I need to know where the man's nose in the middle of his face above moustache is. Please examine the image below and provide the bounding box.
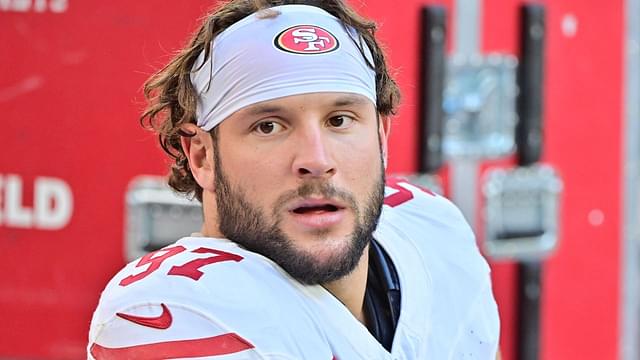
[292,128,336,178]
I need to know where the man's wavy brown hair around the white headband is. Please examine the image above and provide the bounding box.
[140,0,400,201]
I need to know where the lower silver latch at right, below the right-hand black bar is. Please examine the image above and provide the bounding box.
[482,165,562,260]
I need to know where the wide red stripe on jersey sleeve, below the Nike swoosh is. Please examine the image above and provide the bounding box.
[91,333,254,360]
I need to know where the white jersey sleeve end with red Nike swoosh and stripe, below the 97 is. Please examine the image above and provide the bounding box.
[87,303,270,360]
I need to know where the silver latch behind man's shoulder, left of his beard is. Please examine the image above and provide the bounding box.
[125,176,202,261]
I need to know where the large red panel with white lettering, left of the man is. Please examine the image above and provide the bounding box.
[0,0,215,359]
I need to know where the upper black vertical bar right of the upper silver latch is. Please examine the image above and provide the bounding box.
[516,4,545,166]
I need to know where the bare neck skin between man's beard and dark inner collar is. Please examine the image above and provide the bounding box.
[322,246,369,325]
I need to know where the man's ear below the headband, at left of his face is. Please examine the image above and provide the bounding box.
[180,124,215,191]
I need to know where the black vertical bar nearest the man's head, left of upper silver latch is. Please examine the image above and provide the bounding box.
[418,6,447,173]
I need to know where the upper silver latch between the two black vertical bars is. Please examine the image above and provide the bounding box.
[442,54,518,159]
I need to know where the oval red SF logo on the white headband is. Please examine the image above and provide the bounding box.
[273,25,339,54]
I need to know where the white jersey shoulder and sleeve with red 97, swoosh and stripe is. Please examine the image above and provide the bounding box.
[87,239,331,360]
